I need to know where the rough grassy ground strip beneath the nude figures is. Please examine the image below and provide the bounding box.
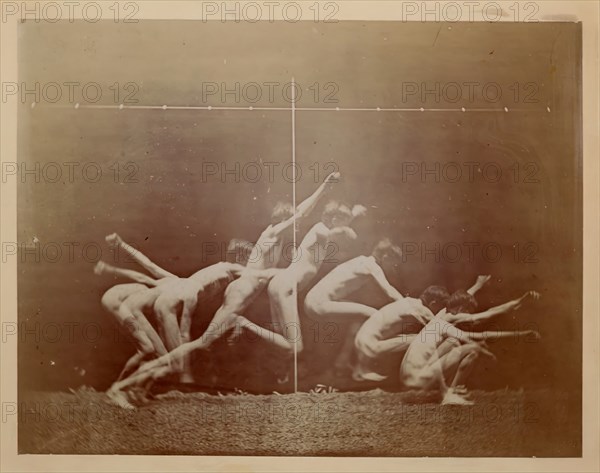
[19,389,580,457]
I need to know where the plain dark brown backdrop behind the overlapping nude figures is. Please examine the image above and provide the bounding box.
[18,21,582,402]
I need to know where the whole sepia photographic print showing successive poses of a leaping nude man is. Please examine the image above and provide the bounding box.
[2,2,597,471]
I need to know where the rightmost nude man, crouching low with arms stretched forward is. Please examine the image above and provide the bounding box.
[400,291,540,405]
